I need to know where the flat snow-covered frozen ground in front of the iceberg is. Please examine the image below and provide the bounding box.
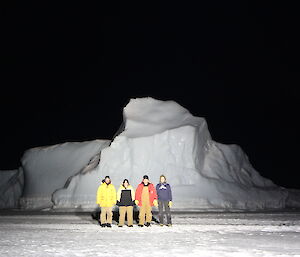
[0,211,300,257]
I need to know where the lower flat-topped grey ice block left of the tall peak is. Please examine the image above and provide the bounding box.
[20,140,110,209]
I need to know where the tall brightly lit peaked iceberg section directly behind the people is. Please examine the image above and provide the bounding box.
[53,97,288,210]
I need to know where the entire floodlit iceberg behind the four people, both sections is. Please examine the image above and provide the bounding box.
[0,97,300,210]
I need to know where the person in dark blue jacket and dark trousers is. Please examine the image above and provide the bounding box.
[156,175,172,226]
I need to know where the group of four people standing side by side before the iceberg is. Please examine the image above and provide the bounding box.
[97,175,172,227]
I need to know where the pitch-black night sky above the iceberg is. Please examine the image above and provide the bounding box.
[0,0,300,188]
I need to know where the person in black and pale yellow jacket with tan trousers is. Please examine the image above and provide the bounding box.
[117,179,135,227]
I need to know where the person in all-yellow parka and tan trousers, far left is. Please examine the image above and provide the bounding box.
[97,176,117,227]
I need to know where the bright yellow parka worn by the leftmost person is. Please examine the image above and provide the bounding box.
[97,182,117,207]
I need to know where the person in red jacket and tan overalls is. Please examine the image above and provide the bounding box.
[135,175,158,227]
